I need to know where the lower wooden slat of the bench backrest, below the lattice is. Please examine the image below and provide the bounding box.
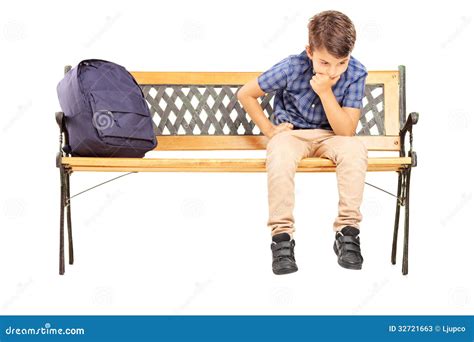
[155,135,400,151]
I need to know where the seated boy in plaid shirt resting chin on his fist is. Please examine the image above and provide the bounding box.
[238,11,367,274]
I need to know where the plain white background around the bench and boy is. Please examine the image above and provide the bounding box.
[0,0,474,314]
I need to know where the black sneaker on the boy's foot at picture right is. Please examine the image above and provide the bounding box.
[333,226,364,270]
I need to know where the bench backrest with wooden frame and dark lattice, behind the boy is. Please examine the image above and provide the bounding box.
[132,66,405,151]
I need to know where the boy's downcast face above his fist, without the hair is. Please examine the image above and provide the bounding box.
[306,45,350,79]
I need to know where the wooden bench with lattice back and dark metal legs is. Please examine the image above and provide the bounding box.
[56,66,418,275]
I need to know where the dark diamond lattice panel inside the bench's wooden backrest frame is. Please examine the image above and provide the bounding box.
[142,84,385,135]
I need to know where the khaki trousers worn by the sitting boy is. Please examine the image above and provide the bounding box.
[266,129,367,236]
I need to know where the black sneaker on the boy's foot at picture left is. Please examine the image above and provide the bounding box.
[271,233,298,274]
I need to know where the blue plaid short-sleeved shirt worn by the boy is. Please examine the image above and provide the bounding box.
[258,51,367,130]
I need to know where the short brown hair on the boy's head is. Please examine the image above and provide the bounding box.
[308,11,356,58]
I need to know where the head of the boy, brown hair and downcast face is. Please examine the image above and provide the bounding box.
[306,11,356,78]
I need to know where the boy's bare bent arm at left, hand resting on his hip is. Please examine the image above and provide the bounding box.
[237,78,293,138]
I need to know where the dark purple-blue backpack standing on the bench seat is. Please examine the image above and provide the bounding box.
[57,59,157,158]
